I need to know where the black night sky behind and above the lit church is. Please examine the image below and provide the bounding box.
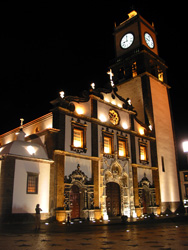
[0,0,188,167]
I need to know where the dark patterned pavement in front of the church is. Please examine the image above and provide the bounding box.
[0,223,188,250]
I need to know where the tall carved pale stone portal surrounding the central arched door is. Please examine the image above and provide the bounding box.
[101,152,136,219]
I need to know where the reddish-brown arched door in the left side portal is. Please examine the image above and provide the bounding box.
[70,185,80,219]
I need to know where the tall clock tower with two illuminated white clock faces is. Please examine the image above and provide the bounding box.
[110,11,180,212]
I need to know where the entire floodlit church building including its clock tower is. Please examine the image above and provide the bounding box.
[0,11,180,221]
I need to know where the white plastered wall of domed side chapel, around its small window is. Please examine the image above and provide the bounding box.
[12,159,50,213]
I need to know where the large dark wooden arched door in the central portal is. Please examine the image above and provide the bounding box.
[106,182,121,217]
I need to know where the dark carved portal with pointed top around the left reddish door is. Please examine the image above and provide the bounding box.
[64,164,94,220]
